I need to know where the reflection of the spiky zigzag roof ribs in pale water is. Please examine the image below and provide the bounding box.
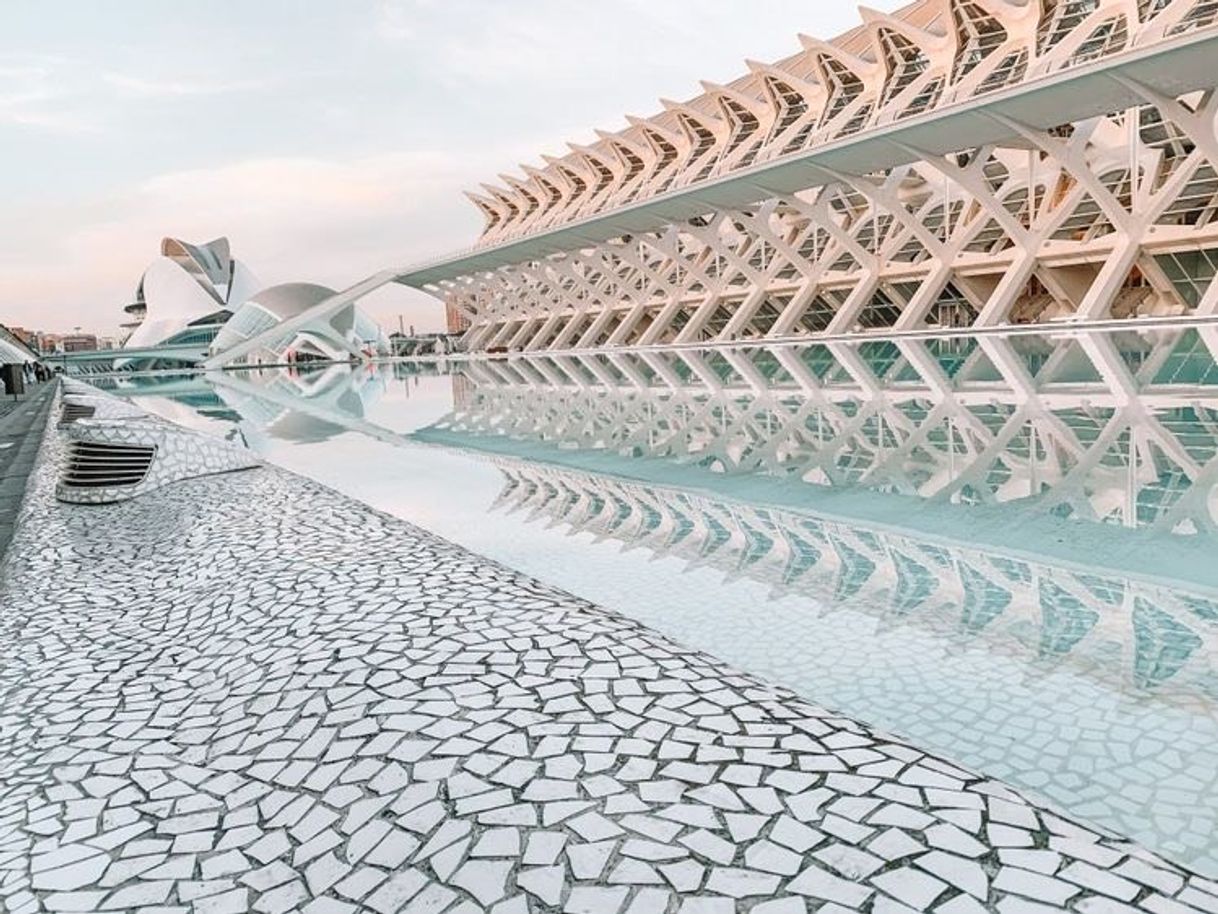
[496,462,1218,687]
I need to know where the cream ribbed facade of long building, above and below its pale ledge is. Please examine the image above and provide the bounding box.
[431,0,1218,351]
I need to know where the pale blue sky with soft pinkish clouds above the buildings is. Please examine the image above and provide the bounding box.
[0,0,898,335]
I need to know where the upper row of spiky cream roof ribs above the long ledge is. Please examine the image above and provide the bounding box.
[468,0,1218,244]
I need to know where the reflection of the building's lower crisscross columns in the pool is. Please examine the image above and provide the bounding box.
[435,328,1218,535]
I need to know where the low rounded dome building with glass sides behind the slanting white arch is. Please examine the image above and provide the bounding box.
[211,283,392,364]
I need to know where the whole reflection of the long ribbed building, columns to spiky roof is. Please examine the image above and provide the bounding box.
[417,330,1218,687]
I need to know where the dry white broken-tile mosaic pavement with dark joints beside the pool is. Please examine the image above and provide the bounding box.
[0,402,1218,914]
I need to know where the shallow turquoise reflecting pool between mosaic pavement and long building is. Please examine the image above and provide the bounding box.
[102,334,1218,874]
